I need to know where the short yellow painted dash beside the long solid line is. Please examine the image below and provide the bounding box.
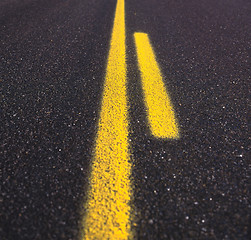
[134,33,179,138]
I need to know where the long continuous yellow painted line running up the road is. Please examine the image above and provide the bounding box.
[84,0,131,239]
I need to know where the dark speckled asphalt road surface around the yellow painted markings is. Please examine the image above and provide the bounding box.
[0,0,251,240]
